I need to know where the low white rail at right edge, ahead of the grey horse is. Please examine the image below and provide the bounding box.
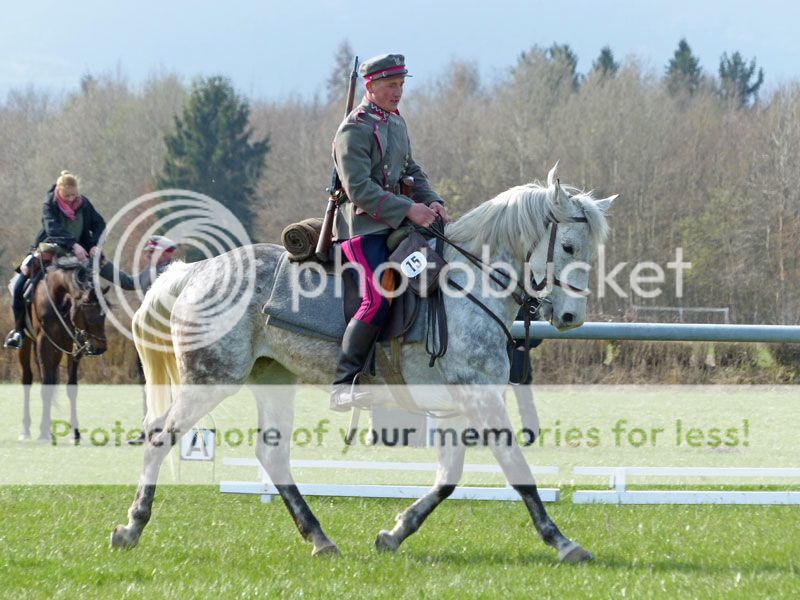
[572,467,800,504]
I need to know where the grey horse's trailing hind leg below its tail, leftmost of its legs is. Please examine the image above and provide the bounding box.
[111,386,229,549]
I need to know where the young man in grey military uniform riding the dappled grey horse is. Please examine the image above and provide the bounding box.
[331,54,449,411]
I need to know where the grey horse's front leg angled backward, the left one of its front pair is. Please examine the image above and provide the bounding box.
[375,417,467,552]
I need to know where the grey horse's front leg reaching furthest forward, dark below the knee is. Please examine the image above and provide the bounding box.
[470,391,593,563]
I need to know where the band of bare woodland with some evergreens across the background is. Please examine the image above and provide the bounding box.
[0,40,800,324]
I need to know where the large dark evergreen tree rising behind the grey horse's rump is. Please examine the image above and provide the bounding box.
[155,76,269,243]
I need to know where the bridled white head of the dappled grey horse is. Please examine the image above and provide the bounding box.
[529,167,618,330]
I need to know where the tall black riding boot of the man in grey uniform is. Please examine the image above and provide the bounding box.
[331,319,380,411]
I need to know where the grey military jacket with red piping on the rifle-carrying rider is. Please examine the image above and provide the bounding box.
[333,98,444,240]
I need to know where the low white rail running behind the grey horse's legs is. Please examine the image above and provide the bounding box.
[219,458,560,502]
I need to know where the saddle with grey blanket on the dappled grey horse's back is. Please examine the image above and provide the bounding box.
[262,247,427,343]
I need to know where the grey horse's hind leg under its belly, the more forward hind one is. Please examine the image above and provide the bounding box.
[253,386,339,556]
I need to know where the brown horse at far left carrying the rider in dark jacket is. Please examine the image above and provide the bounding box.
[19,257,106,443]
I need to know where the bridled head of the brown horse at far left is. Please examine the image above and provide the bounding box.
[67,265,108,356]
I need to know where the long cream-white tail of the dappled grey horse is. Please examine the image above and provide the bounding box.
[132,262,192,428]
